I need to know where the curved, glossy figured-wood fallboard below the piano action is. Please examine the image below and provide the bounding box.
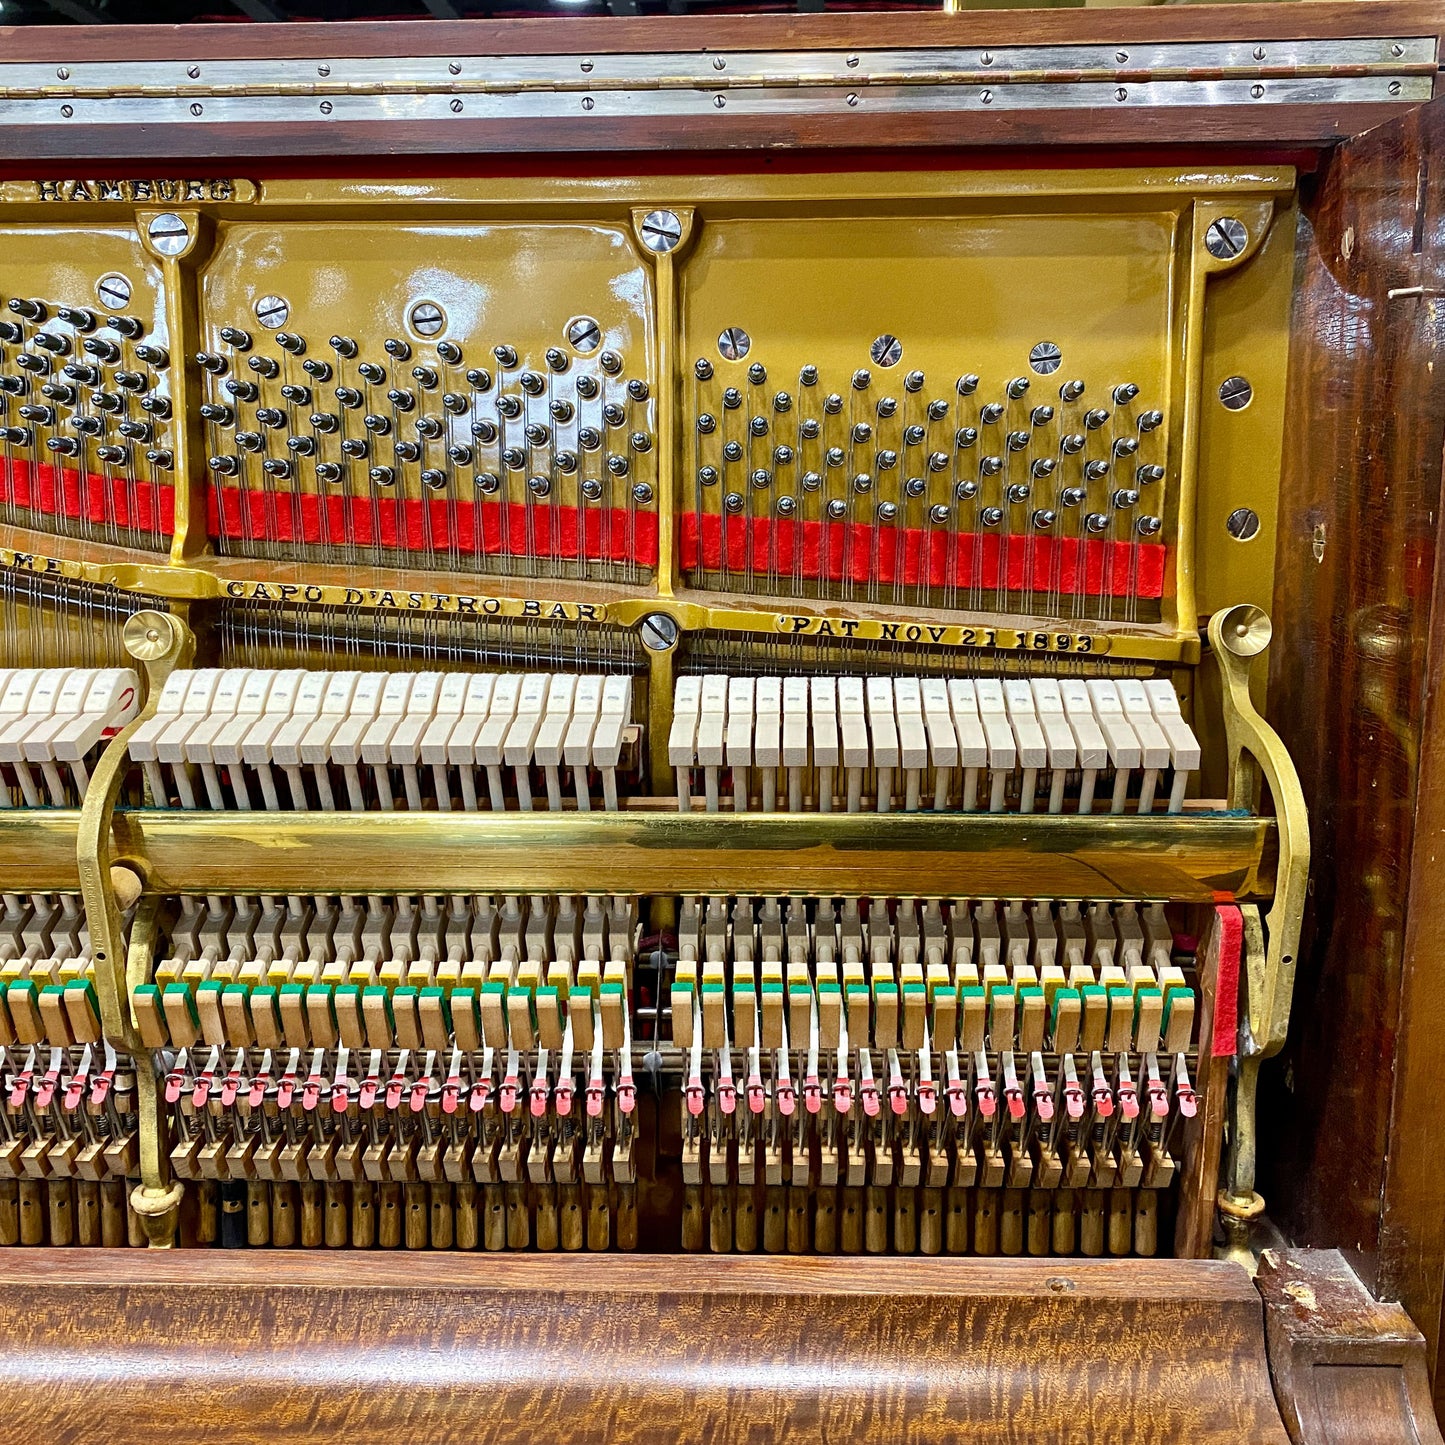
[0,1250,1285,1445]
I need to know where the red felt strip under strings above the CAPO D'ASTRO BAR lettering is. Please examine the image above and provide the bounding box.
[207,487,657,566]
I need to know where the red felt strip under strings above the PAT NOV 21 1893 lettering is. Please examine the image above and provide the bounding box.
[679,512,1165,598]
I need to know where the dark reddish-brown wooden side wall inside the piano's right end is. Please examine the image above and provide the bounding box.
[1260,90,1445,1375]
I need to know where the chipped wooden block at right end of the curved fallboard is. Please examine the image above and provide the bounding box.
[1256,1250,1442,1445]
